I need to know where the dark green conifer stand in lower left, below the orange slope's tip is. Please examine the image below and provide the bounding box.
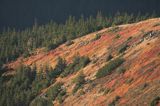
[0,56,89,106]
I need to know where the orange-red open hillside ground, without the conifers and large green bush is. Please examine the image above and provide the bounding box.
[6,18,160,106]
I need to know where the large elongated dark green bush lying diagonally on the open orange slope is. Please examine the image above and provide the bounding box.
[96,57,124,78]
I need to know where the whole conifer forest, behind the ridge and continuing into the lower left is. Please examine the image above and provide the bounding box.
[0,12,156,106]
